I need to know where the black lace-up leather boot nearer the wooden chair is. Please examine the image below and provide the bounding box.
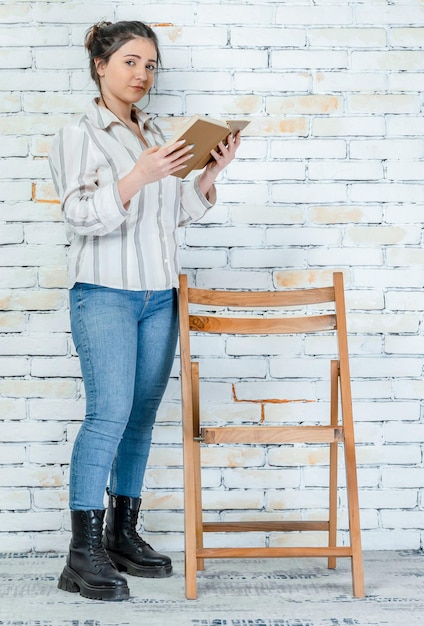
[103,494,172,578]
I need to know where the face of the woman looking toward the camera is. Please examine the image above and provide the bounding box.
[95,37,157,104]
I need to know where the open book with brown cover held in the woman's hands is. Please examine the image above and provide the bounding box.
[165,115,249,178]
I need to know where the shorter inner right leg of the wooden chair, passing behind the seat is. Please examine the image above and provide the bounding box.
[328,360,339,569]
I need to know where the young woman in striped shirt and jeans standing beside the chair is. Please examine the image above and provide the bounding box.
[49,22,240,600]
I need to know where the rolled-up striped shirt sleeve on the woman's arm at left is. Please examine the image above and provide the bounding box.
[49,125,128,236]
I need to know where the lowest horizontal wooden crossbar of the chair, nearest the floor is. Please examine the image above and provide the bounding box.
[198,547,352,559]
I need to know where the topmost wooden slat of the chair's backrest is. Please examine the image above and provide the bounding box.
[188,286,334,308]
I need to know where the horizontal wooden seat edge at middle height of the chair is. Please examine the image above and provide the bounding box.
[200,426,343,444]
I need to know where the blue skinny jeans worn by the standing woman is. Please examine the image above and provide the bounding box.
[69,283,178,510]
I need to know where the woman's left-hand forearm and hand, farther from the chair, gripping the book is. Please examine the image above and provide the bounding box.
[118,140,193,208]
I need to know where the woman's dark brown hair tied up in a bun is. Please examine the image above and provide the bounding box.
[84,21,161,91]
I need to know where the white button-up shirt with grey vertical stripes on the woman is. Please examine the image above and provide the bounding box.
[49,100,212,290]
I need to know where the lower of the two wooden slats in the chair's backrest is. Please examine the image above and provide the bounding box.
[189,314,336,335]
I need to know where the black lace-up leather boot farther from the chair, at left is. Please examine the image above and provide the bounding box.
[58,510,130,600]
